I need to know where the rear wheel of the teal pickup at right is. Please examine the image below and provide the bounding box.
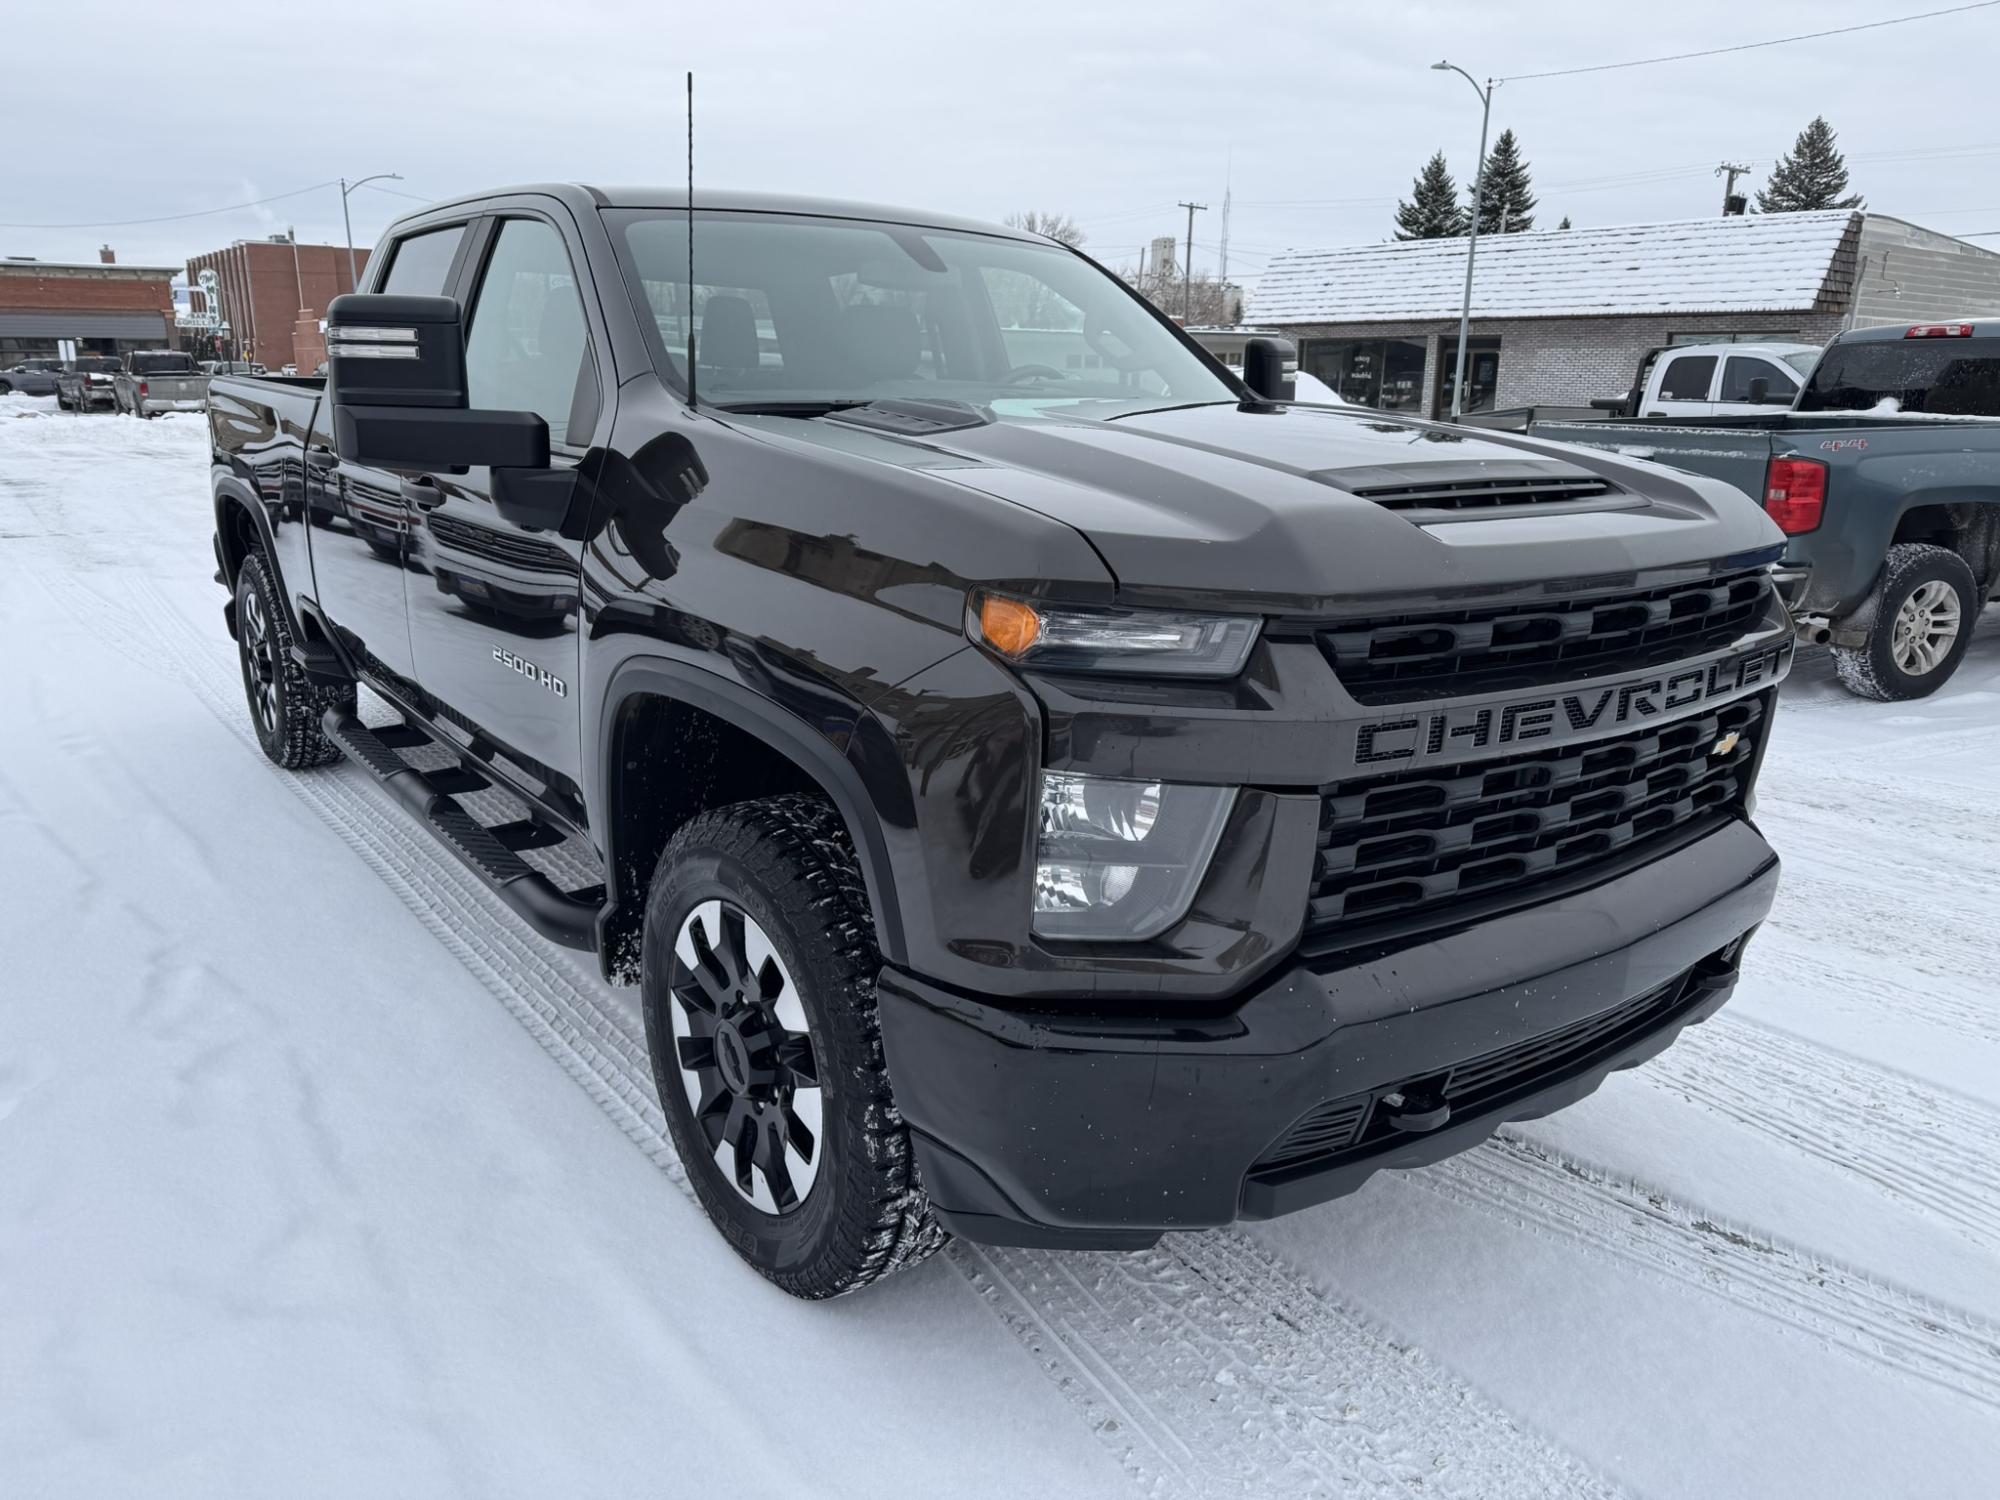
[1834,542,1980,702]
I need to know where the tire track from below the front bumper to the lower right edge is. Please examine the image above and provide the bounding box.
[1408,1136,2000,1410]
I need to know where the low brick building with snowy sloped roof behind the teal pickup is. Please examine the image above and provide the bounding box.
[1252,210,2000,416]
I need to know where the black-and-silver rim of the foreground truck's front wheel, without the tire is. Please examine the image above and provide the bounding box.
[668,900,822,1214]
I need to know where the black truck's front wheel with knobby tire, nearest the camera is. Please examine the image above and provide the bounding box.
[640,796,944,1298]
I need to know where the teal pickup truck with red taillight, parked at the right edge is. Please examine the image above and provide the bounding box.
[1530,322,2000,700]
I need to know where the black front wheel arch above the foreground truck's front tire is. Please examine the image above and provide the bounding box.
[592,656,904,980]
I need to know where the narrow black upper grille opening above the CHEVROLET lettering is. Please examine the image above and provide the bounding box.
[1314,568,1770,704]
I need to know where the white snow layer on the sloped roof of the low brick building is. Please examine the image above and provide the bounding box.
[1256,210,1860,324]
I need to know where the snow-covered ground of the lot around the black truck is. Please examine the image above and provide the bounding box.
[0,398,2000,1500]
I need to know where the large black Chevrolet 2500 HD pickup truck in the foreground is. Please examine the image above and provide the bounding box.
[210,186,1792,1296]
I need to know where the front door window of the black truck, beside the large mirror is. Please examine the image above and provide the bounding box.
[466,218,586,442]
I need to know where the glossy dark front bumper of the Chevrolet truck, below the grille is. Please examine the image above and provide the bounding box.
[878,820,1778,1248]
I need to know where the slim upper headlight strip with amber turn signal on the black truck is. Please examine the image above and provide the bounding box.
[966,594,1262,678]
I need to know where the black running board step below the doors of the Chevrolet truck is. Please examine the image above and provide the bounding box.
[320,708,604,950]
